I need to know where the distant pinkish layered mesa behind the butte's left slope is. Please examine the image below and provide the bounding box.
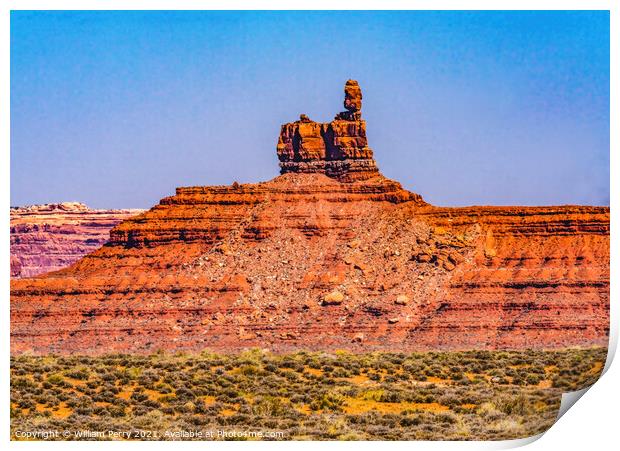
[11,202,143,278]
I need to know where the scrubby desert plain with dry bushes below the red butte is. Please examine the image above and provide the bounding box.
[11,348,606,440]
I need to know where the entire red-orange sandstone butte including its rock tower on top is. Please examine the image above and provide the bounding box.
[11,81,610,354]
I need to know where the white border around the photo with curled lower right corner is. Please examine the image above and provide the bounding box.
[0,0,620,451]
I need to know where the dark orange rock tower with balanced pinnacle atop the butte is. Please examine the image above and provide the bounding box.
[277,80,379,182]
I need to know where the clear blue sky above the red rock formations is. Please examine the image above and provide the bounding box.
[11,11,609,208]
